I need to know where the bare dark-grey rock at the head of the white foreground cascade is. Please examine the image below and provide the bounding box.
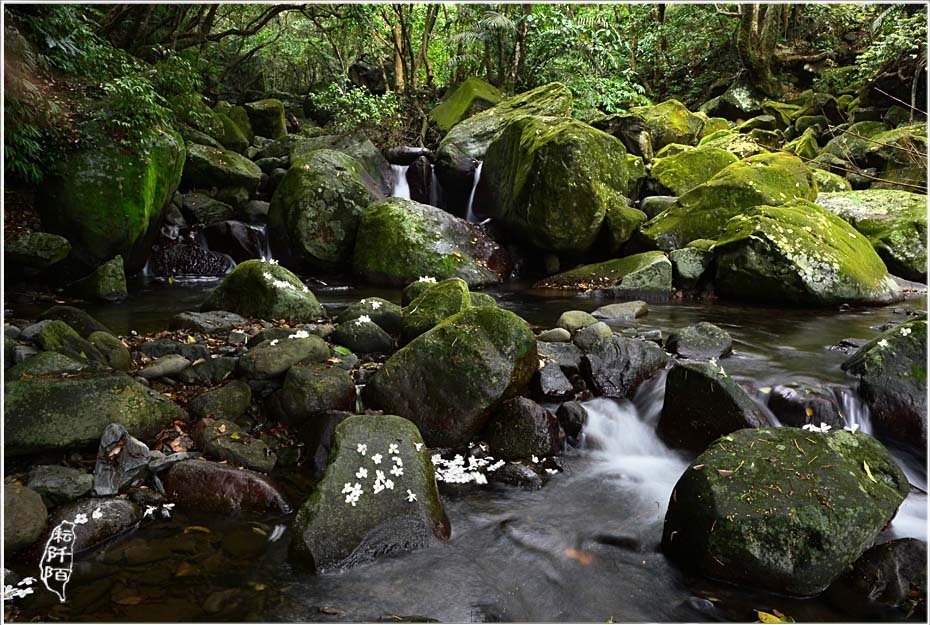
[581,334,668,397]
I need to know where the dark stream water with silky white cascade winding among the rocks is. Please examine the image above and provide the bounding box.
[7,282,927,622]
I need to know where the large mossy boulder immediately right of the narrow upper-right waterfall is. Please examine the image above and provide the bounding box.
[475,116,635,253]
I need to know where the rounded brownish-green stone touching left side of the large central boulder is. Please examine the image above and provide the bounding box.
[273,363,355,426]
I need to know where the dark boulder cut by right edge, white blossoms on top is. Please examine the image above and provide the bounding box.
[843,319,927,458]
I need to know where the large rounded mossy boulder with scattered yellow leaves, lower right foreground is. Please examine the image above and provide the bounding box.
[662,428,908,596]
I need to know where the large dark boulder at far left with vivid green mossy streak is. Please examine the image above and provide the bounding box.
[36,128,185,274]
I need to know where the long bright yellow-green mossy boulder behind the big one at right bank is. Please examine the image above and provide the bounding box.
[640,153,817,250]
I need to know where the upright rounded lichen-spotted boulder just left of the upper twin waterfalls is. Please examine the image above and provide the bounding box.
[268,150,374,270]
